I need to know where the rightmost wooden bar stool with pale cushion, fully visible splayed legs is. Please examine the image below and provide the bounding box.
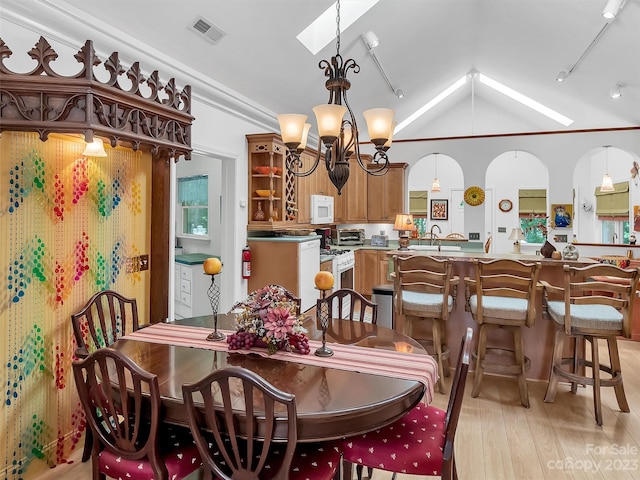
[543,264,639,425]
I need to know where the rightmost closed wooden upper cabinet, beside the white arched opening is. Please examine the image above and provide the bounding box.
[366,163,408,223]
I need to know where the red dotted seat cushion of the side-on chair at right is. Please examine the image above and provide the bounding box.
[343,404,447,476]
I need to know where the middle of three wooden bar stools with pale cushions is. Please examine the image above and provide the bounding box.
[465,259,541,408]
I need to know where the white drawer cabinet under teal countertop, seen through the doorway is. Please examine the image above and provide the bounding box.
[174,262,214,318]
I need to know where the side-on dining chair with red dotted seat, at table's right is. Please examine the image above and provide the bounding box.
[343,328,473,480]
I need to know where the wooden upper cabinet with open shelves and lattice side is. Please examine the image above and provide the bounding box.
[247,133,298,230]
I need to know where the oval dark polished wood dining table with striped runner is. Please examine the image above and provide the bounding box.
[114,314,433,442]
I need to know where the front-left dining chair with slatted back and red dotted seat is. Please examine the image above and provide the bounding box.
[73,348,202,480]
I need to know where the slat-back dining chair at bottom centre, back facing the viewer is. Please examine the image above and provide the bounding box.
[182,367,341,480]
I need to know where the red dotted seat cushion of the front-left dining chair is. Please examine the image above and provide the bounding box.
[98,427,202,480]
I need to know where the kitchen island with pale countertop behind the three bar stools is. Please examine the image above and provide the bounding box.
[387,250,598,380]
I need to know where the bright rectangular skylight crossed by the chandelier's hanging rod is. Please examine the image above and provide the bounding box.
[296,0,379,55]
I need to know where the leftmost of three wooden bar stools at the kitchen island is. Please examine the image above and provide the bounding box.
[394,255,459,393]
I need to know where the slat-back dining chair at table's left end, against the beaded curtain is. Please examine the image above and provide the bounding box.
[71,290,139,462]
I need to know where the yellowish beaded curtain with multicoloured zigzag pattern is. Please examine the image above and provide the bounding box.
[0,132,151,480]
